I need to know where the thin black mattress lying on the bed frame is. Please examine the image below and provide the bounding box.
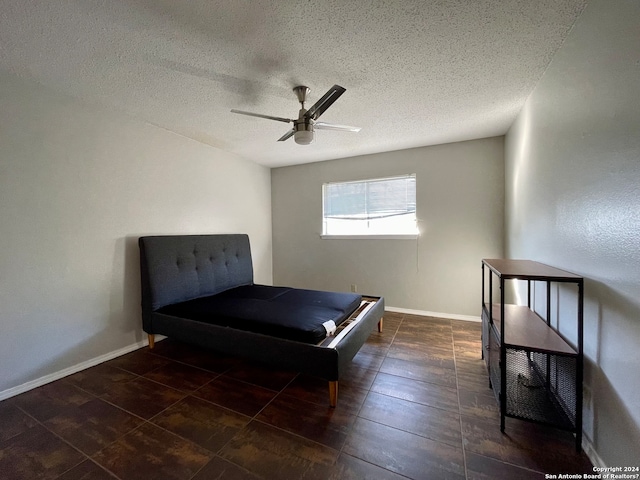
[157,284,362,343]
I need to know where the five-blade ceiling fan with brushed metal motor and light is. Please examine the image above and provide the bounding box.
[231,85,360,145]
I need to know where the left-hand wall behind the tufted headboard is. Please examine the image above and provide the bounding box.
[0,73,272,398]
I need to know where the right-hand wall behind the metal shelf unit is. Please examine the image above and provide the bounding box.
[505,0,640,466]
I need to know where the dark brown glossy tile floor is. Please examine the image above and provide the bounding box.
[0,313,591,480]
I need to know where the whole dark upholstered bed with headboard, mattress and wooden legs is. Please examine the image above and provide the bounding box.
[138,234,384,407]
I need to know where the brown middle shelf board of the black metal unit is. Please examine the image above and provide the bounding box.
[485,303,577,355]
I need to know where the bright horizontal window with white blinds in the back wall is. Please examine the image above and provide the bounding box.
[322,174,418,236]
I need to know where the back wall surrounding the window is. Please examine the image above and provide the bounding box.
[271,137,504,317]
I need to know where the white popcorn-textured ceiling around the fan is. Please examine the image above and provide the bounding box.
[0,0,586,166]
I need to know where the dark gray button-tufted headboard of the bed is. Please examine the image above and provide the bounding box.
[138,234,253,330]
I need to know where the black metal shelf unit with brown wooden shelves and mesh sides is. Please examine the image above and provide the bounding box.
[482,259,584,451]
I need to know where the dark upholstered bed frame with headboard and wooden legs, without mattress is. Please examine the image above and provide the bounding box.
[138,234,384,407]
